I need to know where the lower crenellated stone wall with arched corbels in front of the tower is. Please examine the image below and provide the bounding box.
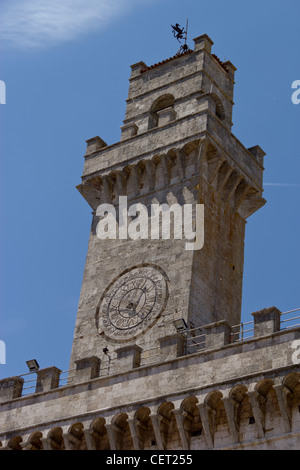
[0,307,300,450]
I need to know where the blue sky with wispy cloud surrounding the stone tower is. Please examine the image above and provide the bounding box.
[0,0,300,377]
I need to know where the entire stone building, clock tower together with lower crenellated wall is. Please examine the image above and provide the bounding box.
[0,35,300,452]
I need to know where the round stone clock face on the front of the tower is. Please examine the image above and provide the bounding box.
[98,266,168,341]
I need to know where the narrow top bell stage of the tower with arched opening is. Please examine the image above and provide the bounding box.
[122,34,236,139]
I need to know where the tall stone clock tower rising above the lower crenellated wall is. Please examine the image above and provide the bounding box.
[70,35,265,382]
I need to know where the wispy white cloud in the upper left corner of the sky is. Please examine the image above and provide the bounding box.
[1,0,143,49]
